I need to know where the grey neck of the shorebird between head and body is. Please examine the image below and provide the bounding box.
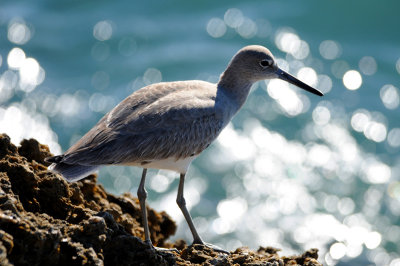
[217,68,253,108]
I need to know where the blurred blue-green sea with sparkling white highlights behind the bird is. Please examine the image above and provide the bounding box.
[0,0,400,266]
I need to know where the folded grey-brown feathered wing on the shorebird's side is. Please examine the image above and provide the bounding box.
[62,82,223,165]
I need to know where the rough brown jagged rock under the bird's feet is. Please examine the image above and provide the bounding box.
[0,134,321,265]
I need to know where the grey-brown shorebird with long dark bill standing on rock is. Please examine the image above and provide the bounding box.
[47,45,323,250]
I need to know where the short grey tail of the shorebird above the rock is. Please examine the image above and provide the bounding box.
[45,155,100,182]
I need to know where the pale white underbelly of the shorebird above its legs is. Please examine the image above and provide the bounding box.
[123,155,197,174]
